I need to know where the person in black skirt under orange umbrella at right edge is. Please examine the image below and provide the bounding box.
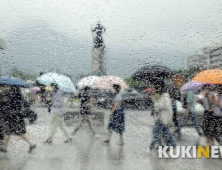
[201,85,222,146]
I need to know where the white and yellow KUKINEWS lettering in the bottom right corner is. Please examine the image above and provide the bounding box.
[158,146,222,159]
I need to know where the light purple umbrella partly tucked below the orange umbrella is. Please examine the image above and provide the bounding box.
[180,80,206,93]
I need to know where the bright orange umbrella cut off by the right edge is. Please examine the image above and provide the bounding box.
[192,69,222,84]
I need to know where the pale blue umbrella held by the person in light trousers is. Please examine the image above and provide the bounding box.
[37,72,76,93]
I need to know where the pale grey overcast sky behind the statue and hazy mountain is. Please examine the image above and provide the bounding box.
[0,0,222,77]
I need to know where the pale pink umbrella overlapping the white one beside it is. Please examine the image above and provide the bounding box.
[95,76,129,90]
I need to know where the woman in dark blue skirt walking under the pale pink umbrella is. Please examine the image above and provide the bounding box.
[104,84,125,145]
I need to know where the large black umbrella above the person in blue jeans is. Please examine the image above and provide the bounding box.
[133,65,173,84]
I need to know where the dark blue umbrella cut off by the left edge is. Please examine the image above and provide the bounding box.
[0,76,29,88]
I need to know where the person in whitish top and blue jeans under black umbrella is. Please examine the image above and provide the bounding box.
[147,84,176,152]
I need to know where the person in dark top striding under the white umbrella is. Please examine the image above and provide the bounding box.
[72,86,95,136]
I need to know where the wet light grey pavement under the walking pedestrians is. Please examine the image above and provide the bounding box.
[0,107,222,170]
